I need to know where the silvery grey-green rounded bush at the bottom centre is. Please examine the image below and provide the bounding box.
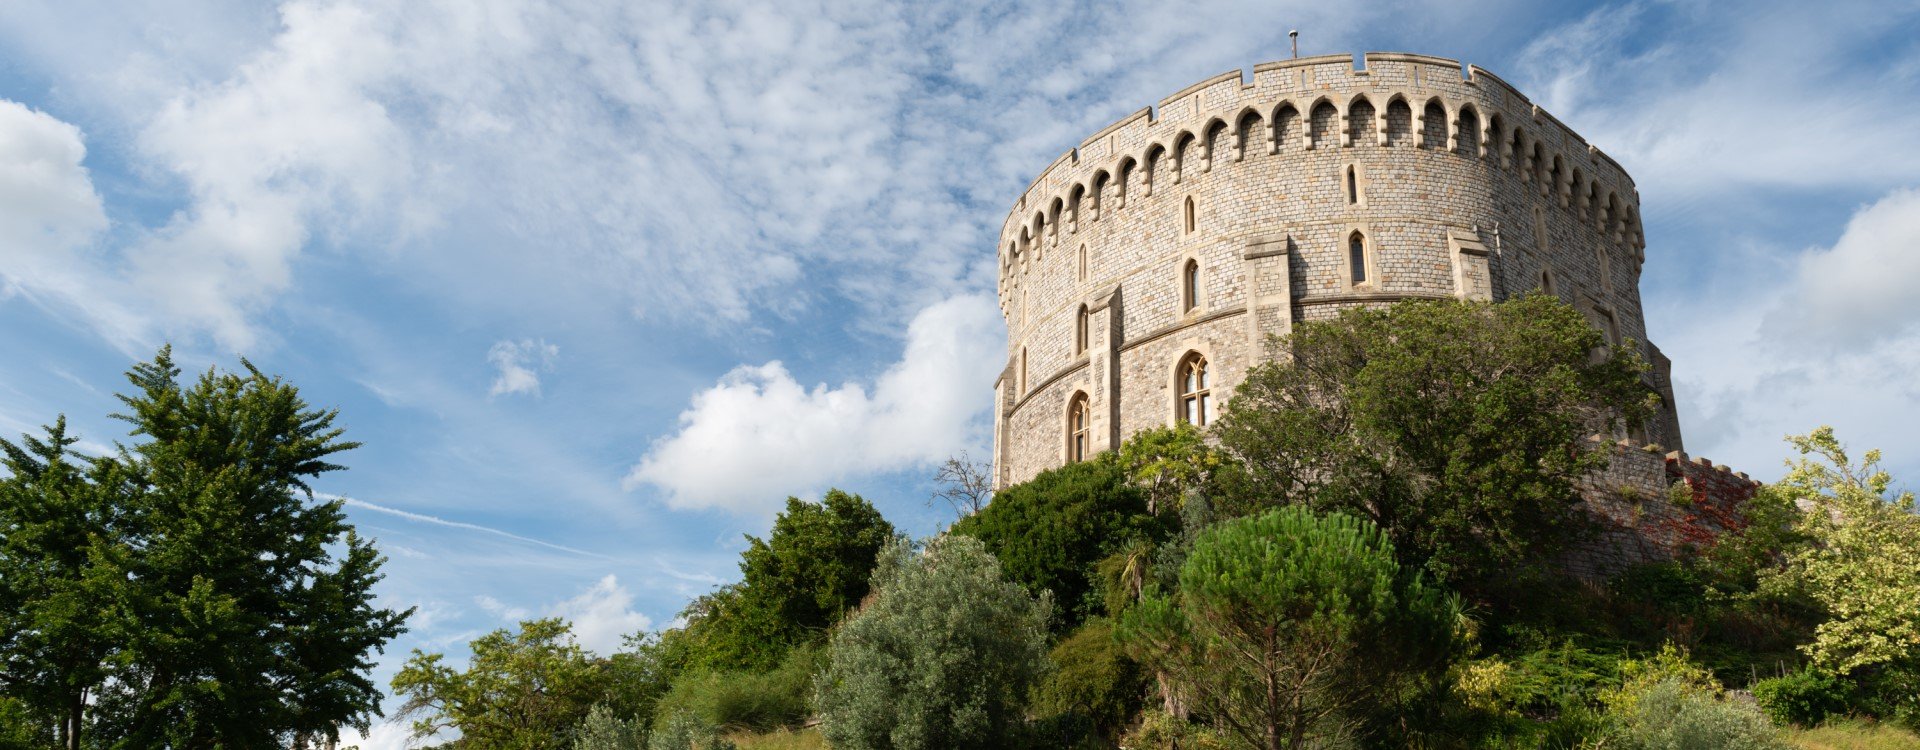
[814,535,1052,750]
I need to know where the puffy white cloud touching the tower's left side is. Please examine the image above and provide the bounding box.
[626,295,1006,512]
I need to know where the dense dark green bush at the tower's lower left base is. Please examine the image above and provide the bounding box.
[952,460,1162,633]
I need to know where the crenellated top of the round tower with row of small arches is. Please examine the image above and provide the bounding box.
[998,52,1645,274]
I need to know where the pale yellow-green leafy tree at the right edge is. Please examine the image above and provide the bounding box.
[1761,428,1920,677]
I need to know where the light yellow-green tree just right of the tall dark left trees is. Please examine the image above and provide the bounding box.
[394,618,609,750]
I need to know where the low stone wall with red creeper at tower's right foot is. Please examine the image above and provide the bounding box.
[1563,443,1761,581]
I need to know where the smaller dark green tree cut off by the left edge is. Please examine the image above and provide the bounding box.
[0,418,125,750]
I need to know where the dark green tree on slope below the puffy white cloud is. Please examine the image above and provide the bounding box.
[687,489,895,669]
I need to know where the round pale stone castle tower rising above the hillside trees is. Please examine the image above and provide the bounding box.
[995,52,1751,568]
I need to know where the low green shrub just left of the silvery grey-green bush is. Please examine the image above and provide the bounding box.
[657,646,826,731]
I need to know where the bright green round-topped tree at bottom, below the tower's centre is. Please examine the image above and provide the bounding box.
[1119,506,1459,750]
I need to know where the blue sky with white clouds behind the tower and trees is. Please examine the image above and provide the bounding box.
[0,0,1920,746]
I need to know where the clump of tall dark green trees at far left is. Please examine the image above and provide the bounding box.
[0,349,407,748]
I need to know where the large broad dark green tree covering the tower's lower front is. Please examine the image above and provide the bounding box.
[1215,295,1655,589]
